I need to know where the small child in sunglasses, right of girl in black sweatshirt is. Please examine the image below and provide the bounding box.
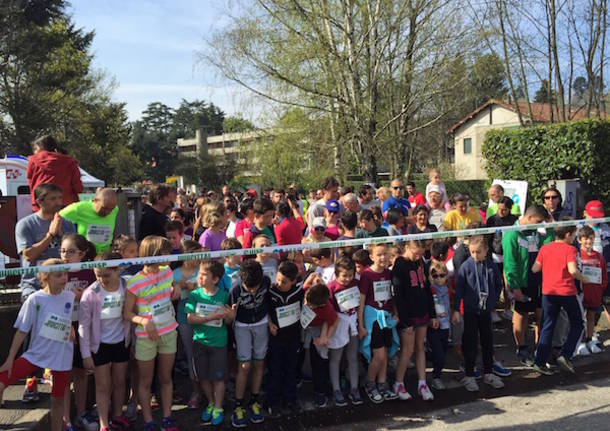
[427,261,451,391]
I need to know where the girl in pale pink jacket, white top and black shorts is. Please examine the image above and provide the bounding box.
[78,252,131,431]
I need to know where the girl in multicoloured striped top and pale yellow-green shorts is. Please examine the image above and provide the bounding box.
[123,235,180,431]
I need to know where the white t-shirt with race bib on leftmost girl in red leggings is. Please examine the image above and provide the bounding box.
[14,290,74,371]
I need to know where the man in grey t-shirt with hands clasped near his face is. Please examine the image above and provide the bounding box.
[15,184,76,301]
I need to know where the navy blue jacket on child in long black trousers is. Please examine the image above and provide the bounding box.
[453,257,502,313]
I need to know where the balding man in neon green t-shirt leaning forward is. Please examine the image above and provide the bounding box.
[59,188,119,254]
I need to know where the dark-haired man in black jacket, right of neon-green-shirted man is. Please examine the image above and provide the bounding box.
[138,184,176,241]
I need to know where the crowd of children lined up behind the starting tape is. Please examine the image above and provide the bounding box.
[0,171,610,431]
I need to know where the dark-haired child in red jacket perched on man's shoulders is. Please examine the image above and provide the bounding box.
[26,135,83,212]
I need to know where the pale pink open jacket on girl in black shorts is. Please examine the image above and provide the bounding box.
[78,277,131,359]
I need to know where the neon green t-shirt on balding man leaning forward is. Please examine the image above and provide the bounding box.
[59,201,119,254]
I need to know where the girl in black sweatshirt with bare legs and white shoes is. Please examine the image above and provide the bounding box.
[392,240,438,401]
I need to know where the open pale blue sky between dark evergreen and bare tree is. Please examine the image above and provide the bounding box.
[68,0,255,120]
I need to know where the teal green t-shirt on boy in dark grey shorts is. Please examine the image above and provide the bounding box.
[185,287,229,347]
